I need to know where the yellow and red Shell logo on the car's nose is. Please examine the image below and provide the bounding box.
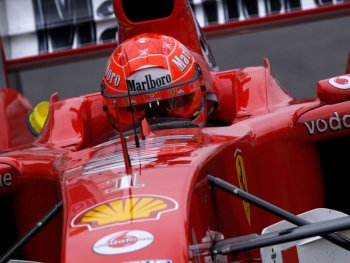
[72,195,178,230]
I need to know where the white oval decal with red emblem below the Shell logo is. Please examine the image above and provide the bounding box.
[93,230,154,255]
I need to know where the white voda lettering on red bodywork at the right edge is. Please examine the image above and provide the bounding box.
[304,112,350,135]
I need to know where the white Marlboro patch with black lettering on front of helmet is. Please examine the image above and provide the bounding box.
[126,68,172,92]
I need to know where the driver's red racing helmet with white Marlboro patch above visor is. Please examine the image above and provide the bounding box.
[101,34,207,130]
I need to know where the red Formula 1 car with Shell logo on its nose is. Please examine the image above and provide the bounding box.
[0,0,350,263]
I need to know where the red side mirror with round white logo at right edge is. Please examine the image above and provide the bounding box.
[317,74,350,104]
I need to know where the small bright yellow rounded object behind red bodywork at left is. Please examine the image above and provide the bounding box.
[27,101,50,136]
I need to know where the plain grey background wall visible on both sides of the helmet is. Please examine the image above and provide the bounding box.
[0,16,350,105]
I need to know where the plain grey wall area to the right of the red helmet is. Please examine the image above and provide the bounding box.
[211,16,350,100]
